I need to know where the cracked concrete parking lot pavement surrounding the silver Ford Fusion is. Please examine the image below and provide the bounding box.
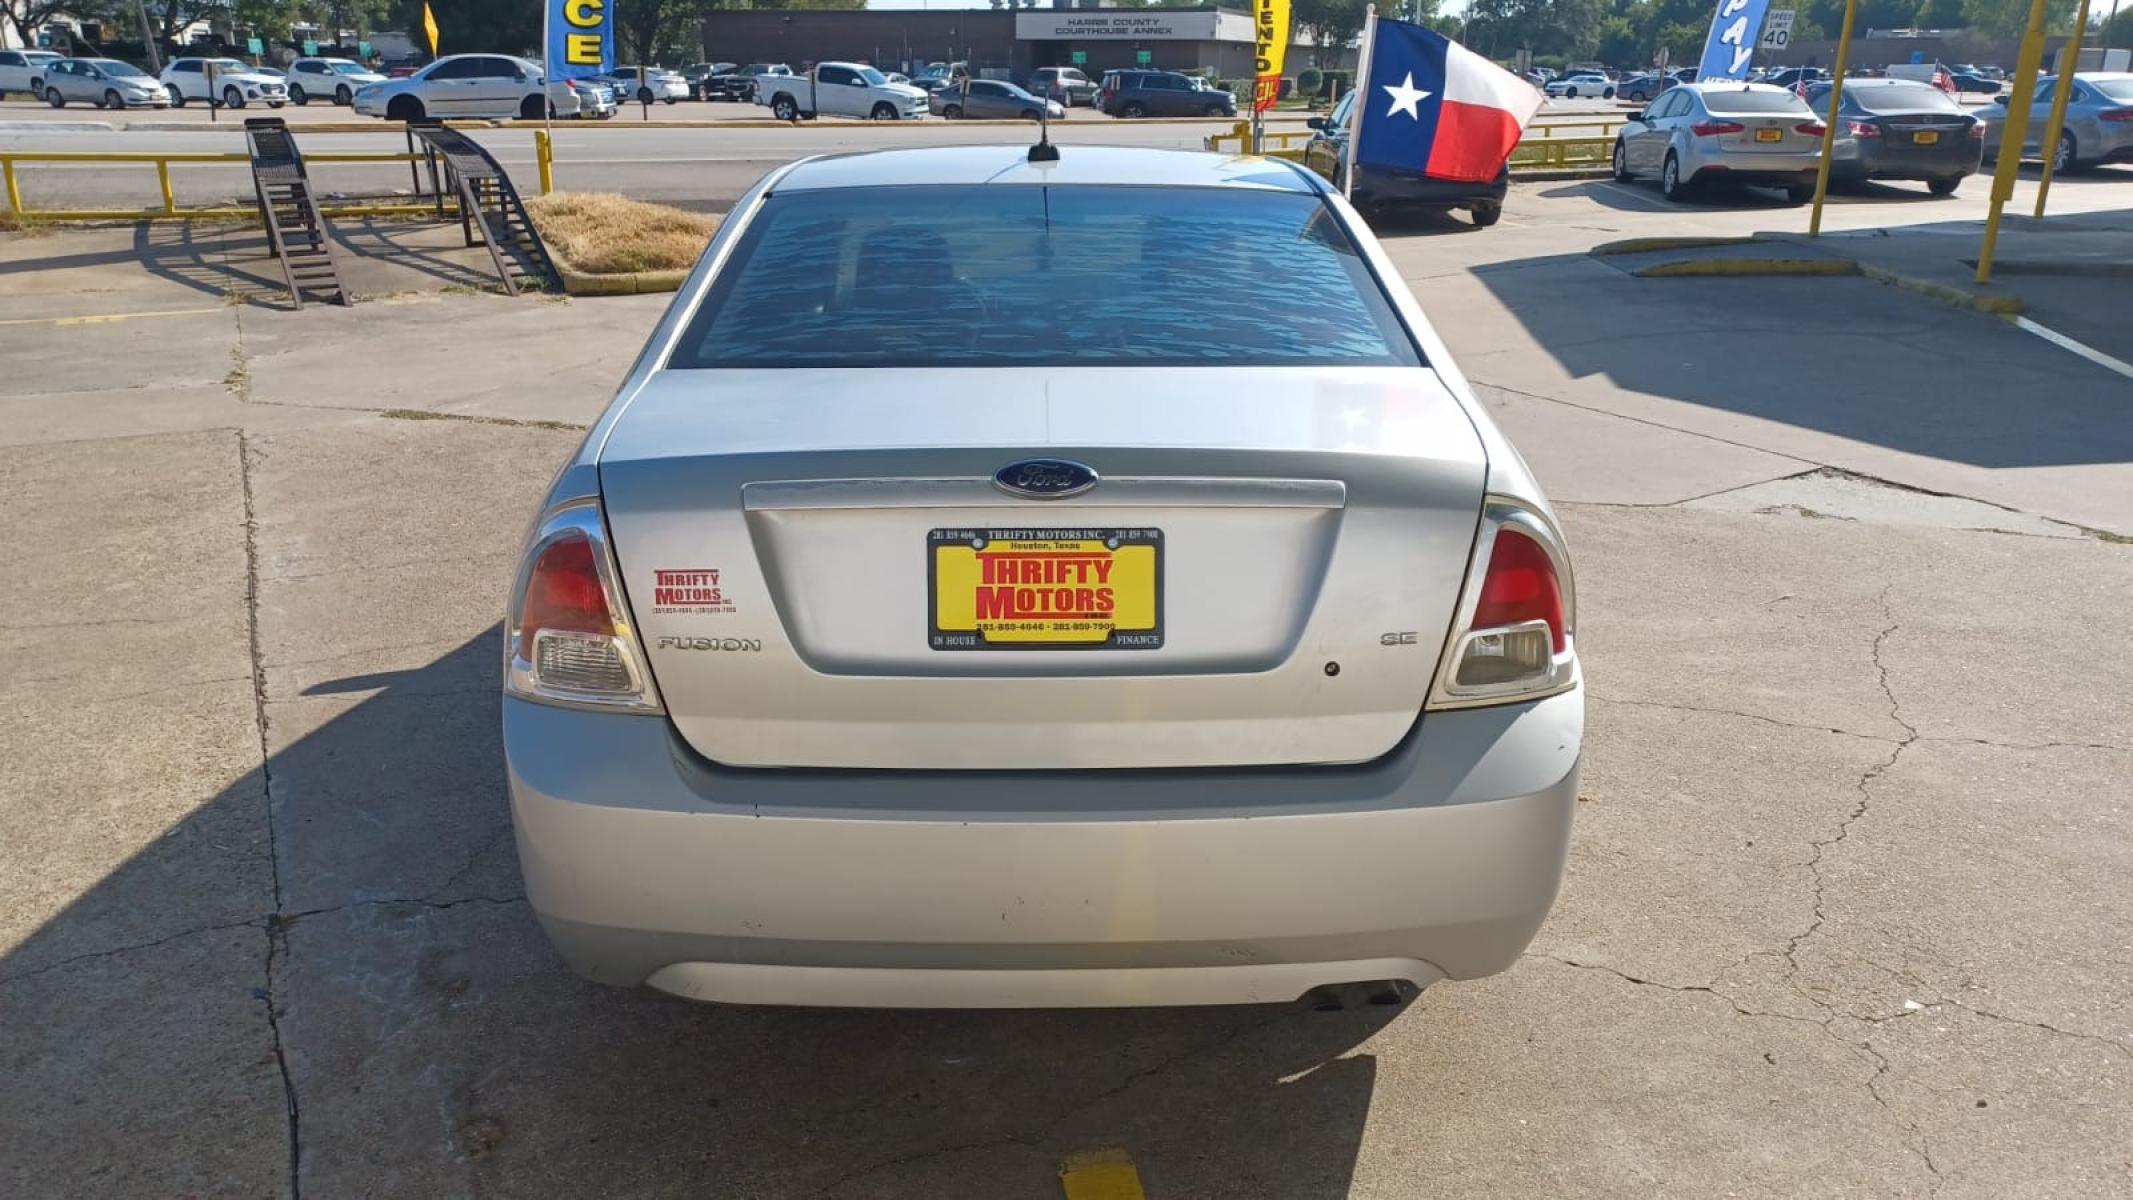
[0,117,2133,1198]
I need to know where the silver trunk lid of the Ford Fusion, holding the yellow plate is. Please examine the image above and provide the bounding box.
[602,367,1487,769]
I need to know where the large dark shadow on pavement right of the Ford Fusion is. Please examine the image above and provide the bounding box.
[1461,206,2133,467]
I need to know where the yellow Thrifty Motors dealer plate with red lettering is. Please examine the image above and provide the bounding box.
[926,529,1162,650]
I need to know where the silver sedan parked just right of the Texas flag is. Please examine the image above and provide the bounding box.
[1615,81,1824,205]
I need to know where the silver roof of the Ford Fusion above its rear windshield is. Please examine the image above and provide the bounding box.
[772,145,1320,192]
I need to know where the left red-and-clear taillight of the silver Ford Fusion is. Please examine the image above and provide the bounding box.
[503,501,661,712]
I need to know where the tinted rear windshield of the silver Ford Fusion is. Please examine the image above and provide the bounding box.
[668,185,1421,367]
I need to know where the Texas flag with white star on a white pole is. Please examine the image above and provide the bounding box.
[1354,19,1540,183]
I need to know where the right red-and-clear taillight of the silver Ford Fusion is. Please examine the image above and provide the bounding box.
[1429,497,1576,708]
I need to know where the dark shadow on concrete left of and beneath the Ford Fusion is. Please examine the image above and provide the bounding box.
[0,627,1421,1198]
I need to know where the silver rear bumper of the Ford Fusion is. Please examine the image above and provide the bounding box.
[503,691,1585,1006]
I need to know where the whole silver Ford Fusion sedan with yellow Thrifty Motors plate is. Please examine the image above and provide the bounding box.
[490,147,1585,1006]
